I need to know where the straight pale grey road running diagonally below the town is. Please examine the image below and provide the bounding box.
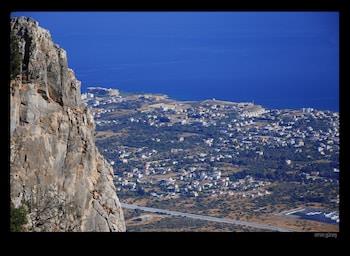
[121,203,294,232]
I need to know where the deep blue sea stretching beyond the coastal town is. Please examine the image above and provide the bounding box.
[12,12,339,111]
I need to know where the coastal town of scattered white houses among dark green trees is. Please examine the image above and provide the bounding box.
[82,87,339,229]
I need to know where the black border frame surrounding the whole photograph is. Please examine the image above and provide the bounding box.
[0,0,350,244]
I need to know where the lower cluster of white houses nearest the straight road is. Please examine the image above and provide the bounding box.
[115,155,271,198]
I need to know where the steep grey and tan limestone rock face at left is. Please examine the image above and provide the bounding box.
[10,17,125,231]
